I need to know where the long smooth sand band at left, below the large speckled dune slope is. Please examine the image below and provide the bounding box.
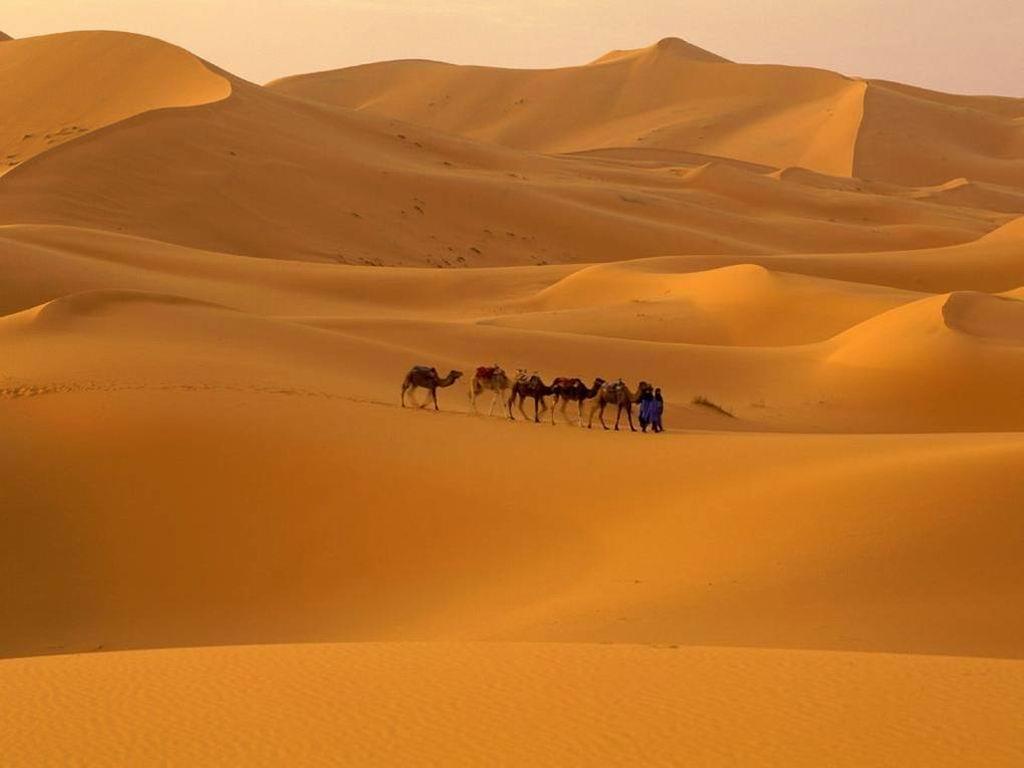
[0,225,580,319]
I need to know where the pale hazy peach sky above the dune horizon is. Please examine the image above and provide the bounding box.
[8,0,1024,96]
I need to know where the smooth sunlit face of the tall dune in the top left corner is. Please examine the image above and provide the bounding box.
[0,32,231,174]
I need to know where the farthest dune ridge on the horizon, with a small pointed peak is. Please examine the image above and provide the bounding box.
[269,39,1024,188]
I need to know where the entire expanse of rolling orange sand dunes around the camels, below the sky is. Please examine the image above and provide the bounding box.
[0,27,1024,767]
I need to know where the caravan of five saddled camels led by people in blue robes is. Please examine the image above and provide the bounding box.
[401,366,665,432]
